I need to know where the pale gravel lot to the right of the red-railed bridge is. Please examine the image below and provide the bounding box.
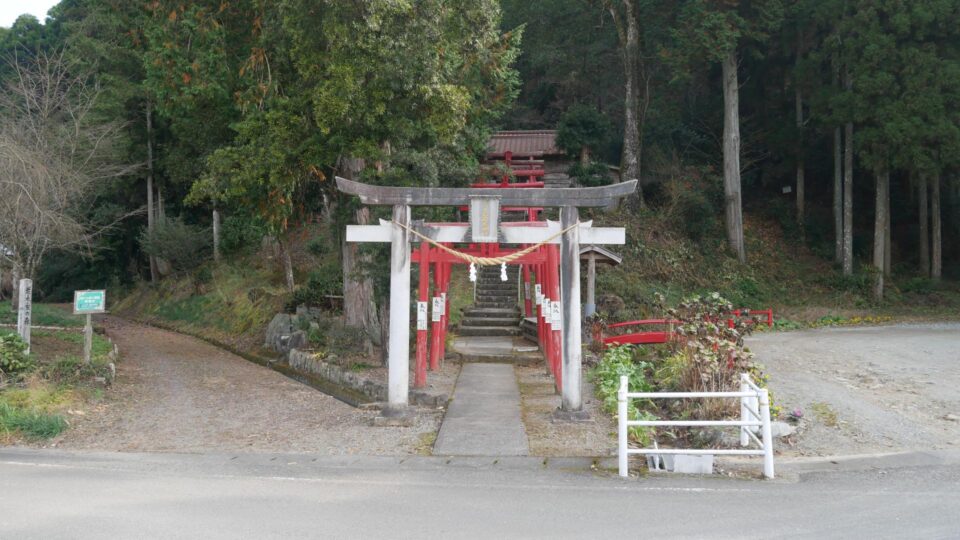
[748,323,960,455]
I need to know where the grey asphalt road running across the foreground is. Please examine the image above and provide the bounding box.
[0,449,960,539]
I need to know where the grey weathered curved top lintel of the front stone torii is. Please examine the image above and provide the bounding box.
[337,176,637,207]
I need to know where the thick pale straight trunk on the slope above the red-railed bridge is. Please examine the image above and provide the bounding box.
[723,49,747,263]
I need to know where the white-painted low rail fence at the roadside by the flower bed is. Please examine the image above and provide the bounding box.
[617,373,773,478]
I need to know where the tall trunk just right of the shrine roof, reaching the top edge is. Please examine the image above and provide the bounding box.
[620,0,643,206]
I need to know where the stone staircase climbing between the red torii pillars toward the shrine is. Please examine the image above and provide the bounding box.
[457,266,520,337]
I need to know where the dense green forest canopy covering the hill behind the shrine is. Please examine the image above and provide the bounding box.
[0,0,960,306]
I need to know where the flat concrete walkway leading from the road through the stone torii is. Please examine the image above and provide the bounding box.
[433,363,530,456]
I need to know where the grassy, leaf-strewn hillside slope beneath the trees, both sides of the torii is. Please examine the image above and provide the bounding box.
[114,209,960,352]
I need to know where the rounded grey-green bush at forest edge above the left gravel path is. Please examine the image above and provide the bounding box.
[140,219,213,272]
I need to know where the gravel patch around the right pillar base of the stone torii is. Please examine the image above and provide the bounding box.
[515,364,617,456]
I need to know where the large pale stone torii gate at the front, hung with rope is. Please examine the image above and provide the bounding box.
[337,177,637,416]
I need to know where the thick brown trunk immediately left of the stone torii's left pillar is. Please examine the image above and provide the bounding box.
[341,158,383,345]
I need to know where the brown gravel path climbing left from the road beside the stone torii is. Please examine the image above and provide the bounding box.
[55,318,439,455]
